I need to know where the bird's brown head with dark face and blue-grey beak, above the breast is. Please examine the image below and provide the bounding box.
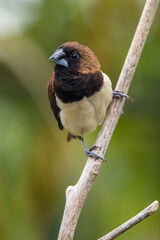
[49,42,100,74]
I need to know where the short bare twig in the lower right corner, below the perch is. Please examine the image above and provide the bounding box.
[98,201,159,240]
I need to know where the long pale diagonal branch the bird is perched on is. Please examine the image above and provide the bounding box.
[58,0,160,240]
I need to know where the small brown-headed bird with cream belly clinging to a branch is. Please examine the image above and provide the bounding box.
[48,41,129,160]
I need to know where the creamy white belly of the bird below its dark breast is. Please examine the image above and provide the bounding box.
[56,73,112,136]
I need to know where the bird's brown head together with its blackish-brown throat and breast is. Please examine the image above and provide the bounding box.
[49,42,103,103]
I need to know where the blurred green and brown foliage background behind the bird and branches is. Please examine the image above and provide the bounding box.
[0,0,160,240]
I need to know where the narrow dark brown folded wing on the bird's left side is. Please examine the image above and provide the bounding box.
[48,72,63,130]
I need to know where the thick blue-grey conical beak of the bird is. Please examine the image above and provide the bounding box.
[49,48,68,68]
